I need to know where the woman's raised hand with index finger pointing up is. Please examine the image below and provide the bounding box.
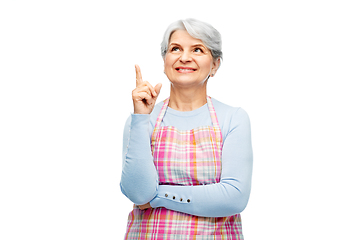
[132,65,161,114]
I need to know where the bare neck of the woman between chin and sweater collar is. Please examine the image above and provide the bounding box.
[169,84,207,112]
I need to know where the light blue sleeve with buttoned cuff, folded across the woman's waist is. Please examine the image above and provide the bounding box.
[150,108,253,217]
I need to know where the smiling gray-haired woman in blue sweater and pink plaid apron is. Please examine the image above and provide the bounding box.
[120,19,252,239]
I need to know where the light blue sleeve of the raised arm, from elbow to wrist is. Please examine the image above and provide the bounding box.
[120,114,158,205]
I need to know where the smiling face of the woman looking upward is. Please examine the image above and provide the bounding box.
[164,30,220,87]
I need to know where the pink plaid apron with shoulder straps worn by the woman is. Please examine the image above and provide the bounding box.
[125,97,243,240]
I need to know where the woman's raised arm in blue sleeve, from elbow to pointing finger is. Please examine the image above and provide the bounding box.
[120,65,161,205]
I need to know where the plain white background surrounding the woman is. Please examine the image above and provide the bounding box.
[0,0,360,240]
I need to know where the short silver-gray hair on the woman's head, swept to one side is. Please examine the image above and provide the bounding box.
[161,18,222,61]
